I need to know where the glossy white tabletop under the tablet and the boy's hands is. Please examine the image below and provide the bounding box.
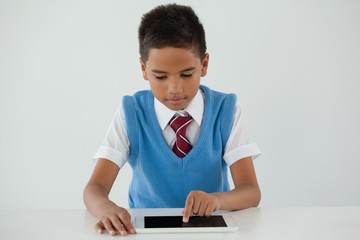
[0,206,360,240]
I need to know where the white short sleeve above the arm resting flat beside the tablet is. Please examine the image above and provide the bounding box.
[93,104,130,168]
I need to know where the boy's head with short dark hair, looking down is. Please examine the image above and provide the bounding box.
[139,4,209,111]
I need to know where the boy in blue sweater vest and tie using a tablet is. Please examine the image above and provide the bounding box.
[84,4,260,235]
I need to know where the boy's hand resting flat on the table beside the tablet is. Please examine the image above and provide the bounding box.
[95,204,135,236]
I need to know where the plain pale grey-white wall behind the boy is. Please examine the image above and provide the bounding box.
[0,0,360,209]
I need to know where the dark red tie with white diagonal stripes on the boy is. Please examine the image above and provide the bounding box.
[169,115,193,158]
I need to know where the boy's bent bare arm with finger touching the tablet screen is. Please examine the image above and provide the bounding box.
[183,157,261,222]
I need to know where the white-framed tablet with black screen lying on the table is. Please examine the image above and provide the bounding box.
[133,215,238,233]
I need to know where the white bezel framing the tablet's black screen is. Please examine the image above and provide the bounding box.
[132,214,239,233]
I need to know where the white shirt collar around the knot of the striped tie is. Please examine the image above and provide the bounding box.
[154,90,204,130]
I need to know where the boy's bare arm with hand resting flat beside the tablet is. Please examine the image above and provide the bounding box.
[83,159,135,235]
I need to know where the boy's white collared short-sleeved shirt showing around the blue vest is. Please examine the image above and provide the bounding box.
[94,90,261,168]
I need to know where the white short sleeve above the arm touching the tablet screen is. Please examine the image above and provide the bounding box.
[224,105,261,166]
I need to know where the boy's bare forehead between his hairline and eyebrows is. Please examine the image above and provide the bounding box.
[146,47,201,70]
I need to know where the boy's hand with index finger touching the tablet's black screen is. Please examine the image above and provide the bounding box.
[183,191,220,222]
